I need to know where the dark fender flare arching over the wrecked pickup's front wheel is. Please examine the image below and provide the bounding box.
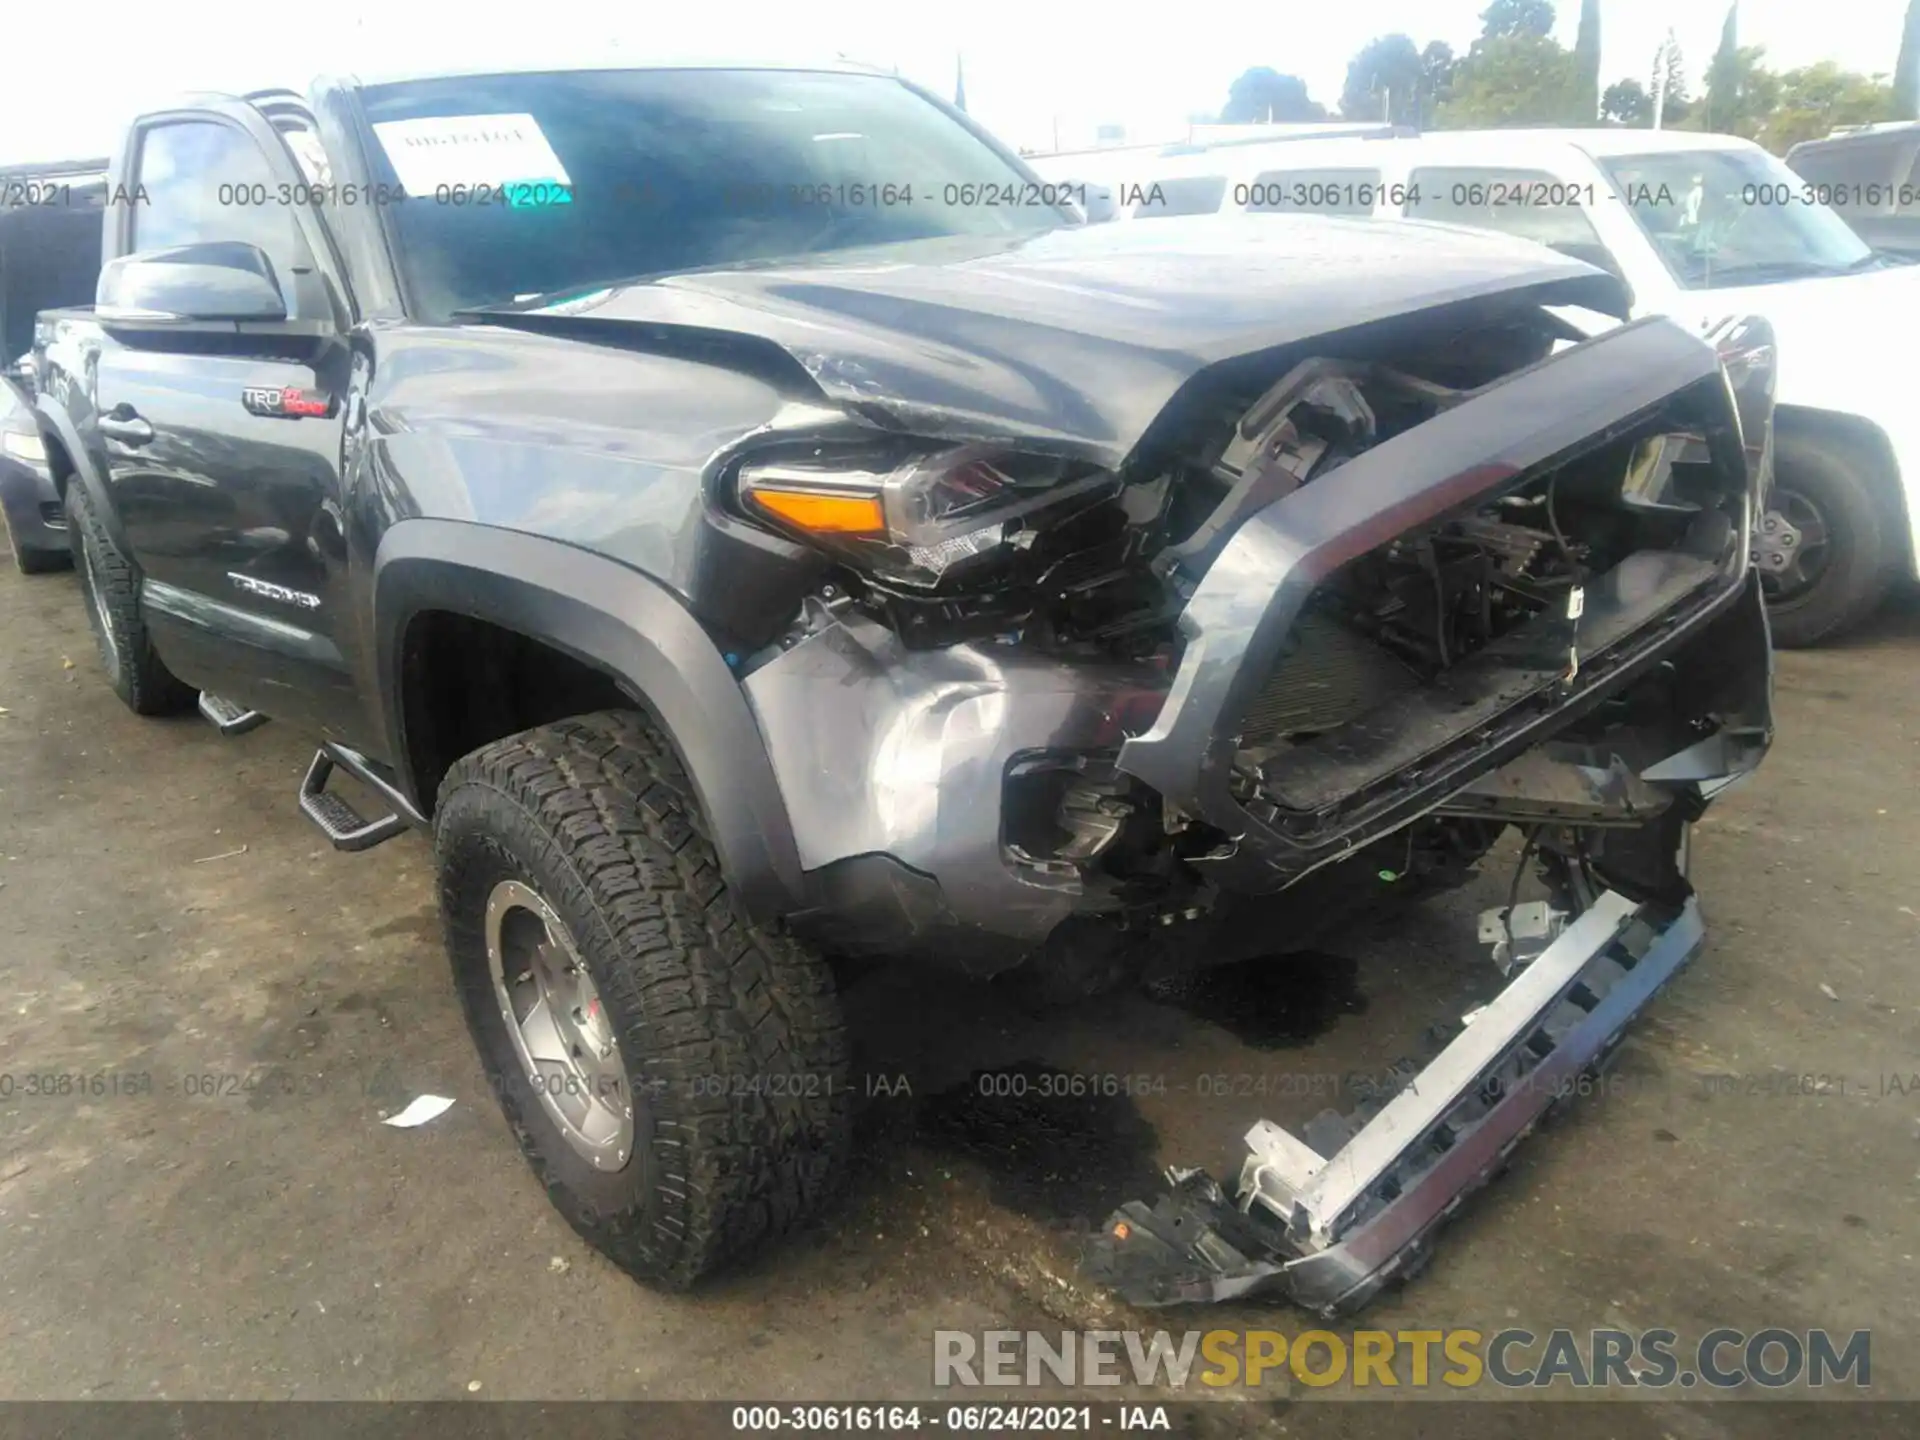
[372,518,803,920]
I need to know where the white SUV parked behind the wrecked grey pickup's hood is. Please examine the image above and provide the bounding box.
[1033,129,1920,645]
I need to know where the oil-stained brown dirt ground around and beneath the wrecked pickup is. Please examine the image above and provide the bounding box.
[0,549,1920,1440]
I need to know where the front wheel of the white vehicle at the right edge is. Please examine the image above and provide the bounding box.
[1763,434,1895,649]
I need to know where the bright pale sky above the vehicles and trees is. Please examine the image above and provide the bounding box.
[0,0,1907,163]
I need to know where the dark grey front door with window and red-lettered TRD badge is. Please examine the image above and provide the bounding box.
[94,106,363,741]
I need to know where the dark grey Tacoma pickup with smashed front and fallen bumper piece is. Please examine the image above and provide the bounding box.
[22,69,1772,1309]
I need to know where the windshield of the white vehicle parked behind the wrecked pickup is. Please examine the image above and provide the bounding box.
[1601,150,1876,290]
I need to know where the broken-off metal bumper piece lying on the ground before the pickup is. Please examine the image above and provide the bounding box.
[1085,891,1705,1319]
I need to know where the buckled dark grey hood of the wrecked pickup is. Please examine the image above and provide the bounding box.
[488,217,1619,463]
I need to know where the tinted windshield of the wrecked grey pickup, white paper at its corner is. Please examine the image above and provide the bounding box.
[363,69,1071,319]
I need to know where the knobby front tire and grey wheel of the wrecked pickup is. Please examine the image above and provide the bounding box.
[434,712,852,1288]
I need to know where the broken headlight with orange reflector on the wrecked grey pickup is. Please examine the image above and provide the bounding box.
[737,445,1119,589]
